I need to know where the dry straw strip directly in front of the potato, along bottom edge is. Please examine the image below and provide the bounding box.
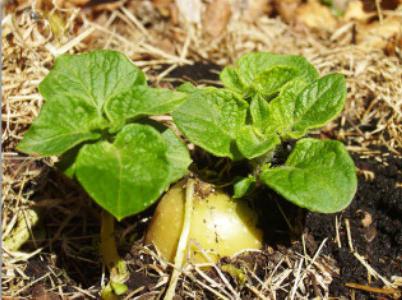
[127,241,339,299]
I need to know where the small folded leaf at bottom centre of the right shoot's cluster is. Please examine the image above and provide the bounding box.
[236,125,280,159]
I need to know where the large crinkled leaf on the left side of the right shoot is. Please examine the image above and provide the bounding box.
[172,88,248,159]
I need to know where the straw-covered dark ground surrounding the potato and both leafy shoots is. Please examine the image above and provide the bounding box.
[2,0,402,299]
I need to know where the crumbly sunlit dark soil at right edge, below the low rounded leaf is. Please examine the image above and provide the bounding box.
[305,156,402,299]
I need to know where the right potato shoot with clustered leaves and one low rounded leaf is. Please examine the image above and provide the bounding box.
[173,52,357,213]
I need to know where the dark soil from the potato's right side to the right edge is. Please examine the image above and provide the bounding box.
[239,151,402,299]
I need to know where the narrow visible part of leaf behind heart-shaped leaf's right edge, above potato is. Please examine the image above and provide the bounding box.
[162,129,192,183]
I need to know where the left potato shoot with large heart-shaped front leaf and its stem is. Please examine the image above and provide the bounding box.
[18,50,191,298]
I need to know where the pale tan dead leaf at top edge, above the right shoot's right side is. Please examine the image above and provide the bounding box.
[296,0,338,32]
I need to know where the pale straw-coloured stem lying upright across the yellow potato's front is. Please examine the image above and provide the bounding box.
[164,179,194,300]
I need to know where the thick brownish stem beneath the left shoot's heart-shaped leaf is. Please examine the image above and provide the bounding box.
[100,210,129,299]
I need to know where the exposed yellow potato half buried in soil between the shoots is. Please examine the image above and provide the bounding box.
[145,181,262,263]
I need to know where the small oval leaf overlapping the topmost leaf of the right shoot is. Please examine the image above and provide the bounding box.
[253,66,299,97]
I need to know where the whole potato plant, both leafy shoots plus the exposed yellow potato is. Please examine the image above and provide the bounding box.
[18,50,356,298]
